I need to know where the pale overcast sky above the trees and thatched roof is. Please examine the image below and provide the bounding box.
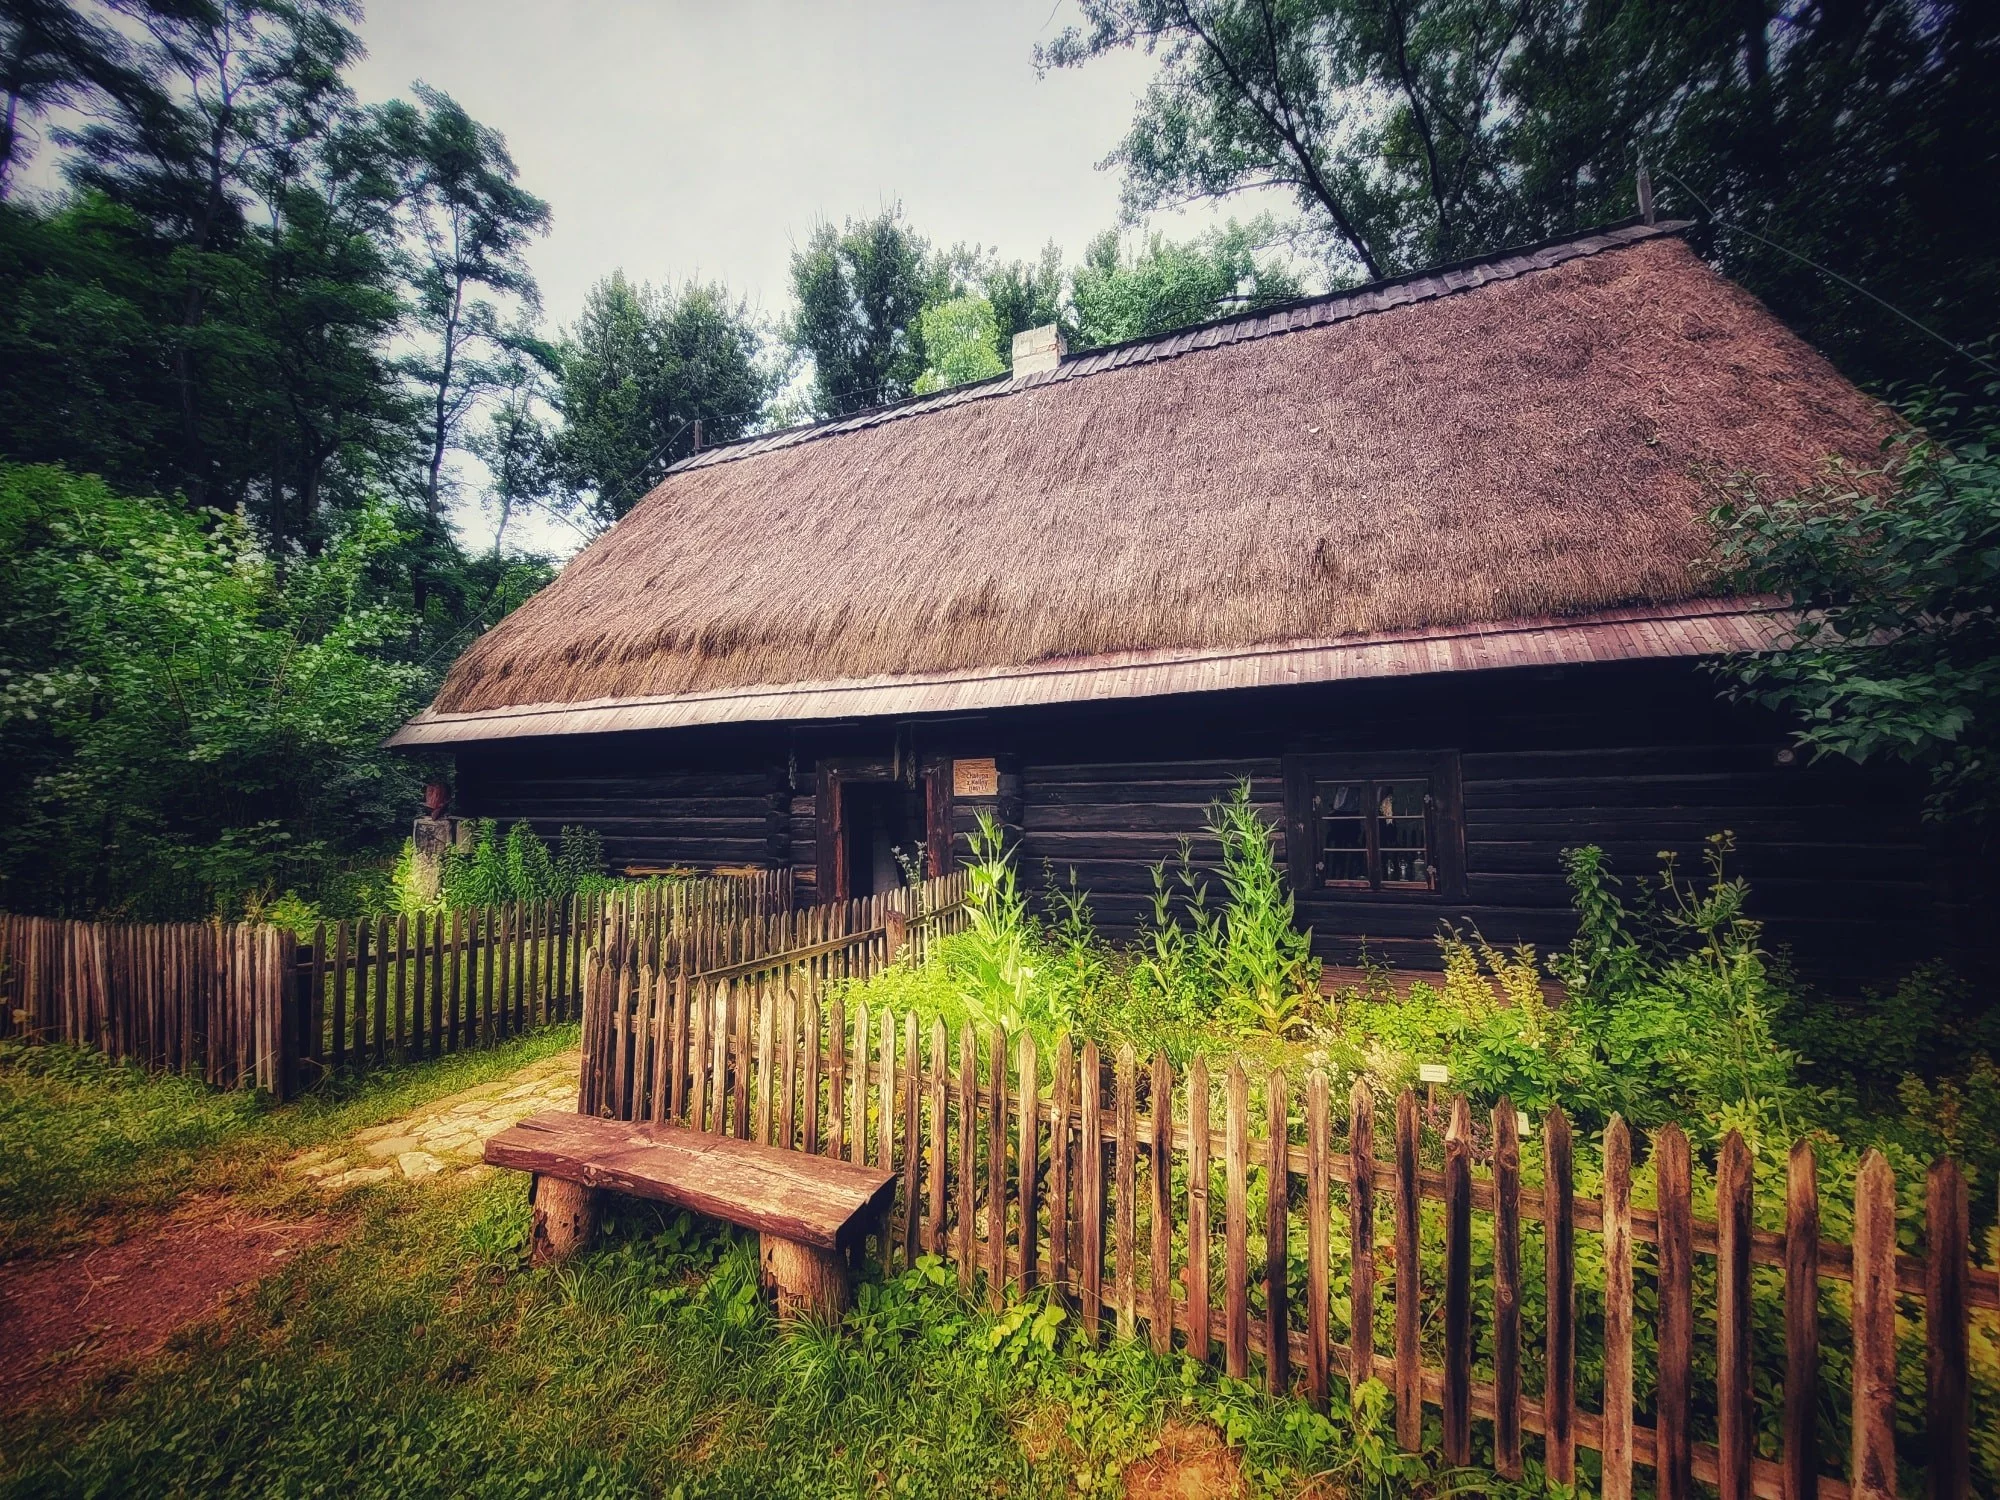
[354,0,1216,334]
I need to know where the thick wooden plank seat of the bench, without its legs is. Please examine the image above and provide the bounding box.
[486,1112,896,1250]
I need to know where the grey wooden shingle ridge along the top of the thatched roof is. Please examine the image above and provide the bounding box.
[666,220,1692,474]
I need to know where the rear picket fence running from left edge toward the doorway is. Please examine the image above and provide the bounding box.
[0,870,812,1098]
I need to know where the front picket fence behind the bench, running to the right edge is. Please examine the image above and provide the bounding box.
[580,964,2000,1500]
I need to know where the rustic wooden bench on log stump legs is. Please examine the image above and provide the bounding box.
[486,1112,896,1318]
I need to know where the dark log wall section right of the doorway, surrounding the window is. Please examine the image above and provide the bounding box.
[976,664,1962,976]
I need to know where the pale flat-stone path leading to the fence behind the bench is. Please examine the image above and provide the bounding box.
[286,1052,582,1192]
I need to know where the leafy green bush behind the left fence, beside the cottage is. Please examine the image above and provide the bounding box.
[0,466,432,918]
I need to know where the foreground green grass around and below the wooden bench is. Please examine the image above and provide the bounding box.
[0,1176,1456,1500]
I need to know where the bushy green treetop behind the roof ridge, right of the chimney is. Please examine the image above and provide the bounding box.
[1070,222,1300,348]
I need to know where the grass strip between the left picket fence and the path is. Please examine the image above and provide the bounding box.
[0,1026,576,1260]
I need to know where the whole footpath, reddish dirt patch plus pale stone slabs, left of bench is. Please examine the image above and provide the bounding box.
[0,1052,578,1410]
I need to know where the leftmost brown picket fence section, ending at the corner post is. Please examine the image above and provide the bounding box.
[0,914,298,1098]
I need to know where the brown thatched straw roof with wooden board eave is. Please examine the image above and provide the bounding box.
[398,226,1890,744]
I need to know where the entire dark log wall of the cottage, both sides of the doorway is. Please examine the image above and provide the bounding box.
[446,662,1966,976]
